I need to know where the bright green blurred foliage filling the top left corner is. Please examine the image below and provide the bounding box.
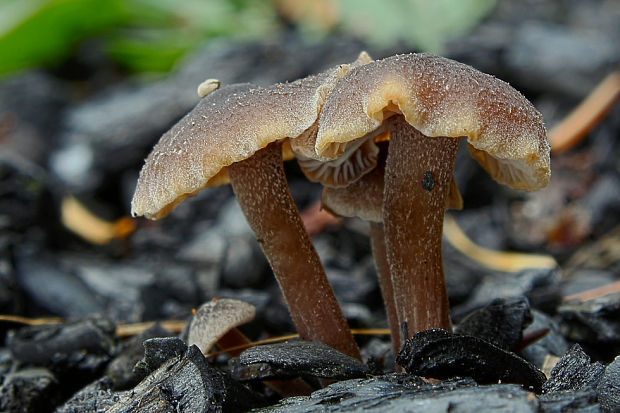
[0,0,279,75]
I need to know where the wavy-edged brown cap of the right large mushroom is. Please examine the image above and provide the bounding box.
[315,54,550,190]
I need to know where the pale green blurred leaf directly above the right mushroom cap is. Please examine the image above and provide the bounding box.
[336,0,495,53]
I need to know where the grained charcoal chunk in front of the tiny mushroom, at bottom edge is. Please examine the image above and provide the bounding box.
[107,346,264,413]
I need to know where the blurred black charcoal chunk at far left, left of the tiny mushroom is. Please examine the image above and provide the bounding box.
[7,317,115,371]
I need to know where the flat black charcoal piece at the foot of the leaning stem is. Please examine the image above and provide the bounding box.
[231,341,369,380]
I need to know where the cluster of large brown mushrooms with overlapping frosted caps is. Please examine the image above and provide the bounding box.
[132,53,549,358]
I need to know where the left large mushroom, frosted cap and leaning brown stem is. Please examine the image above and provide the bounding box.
[132,54,369,358]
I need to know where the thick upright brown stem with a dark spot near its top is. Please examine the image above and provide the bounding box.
[383,116,459,338]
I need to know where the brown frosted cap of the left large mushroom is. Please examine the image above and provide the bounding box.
[132,53,370,219]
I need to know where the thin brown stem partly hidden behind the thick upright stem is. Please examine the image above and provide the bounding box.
[370,222,402,357]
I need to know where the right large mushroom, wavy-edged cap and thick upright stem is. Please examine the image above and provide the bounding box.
[315,54,550,338]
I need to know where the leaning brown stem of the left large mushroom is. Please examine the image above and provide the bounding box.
[227,143,360,359]
